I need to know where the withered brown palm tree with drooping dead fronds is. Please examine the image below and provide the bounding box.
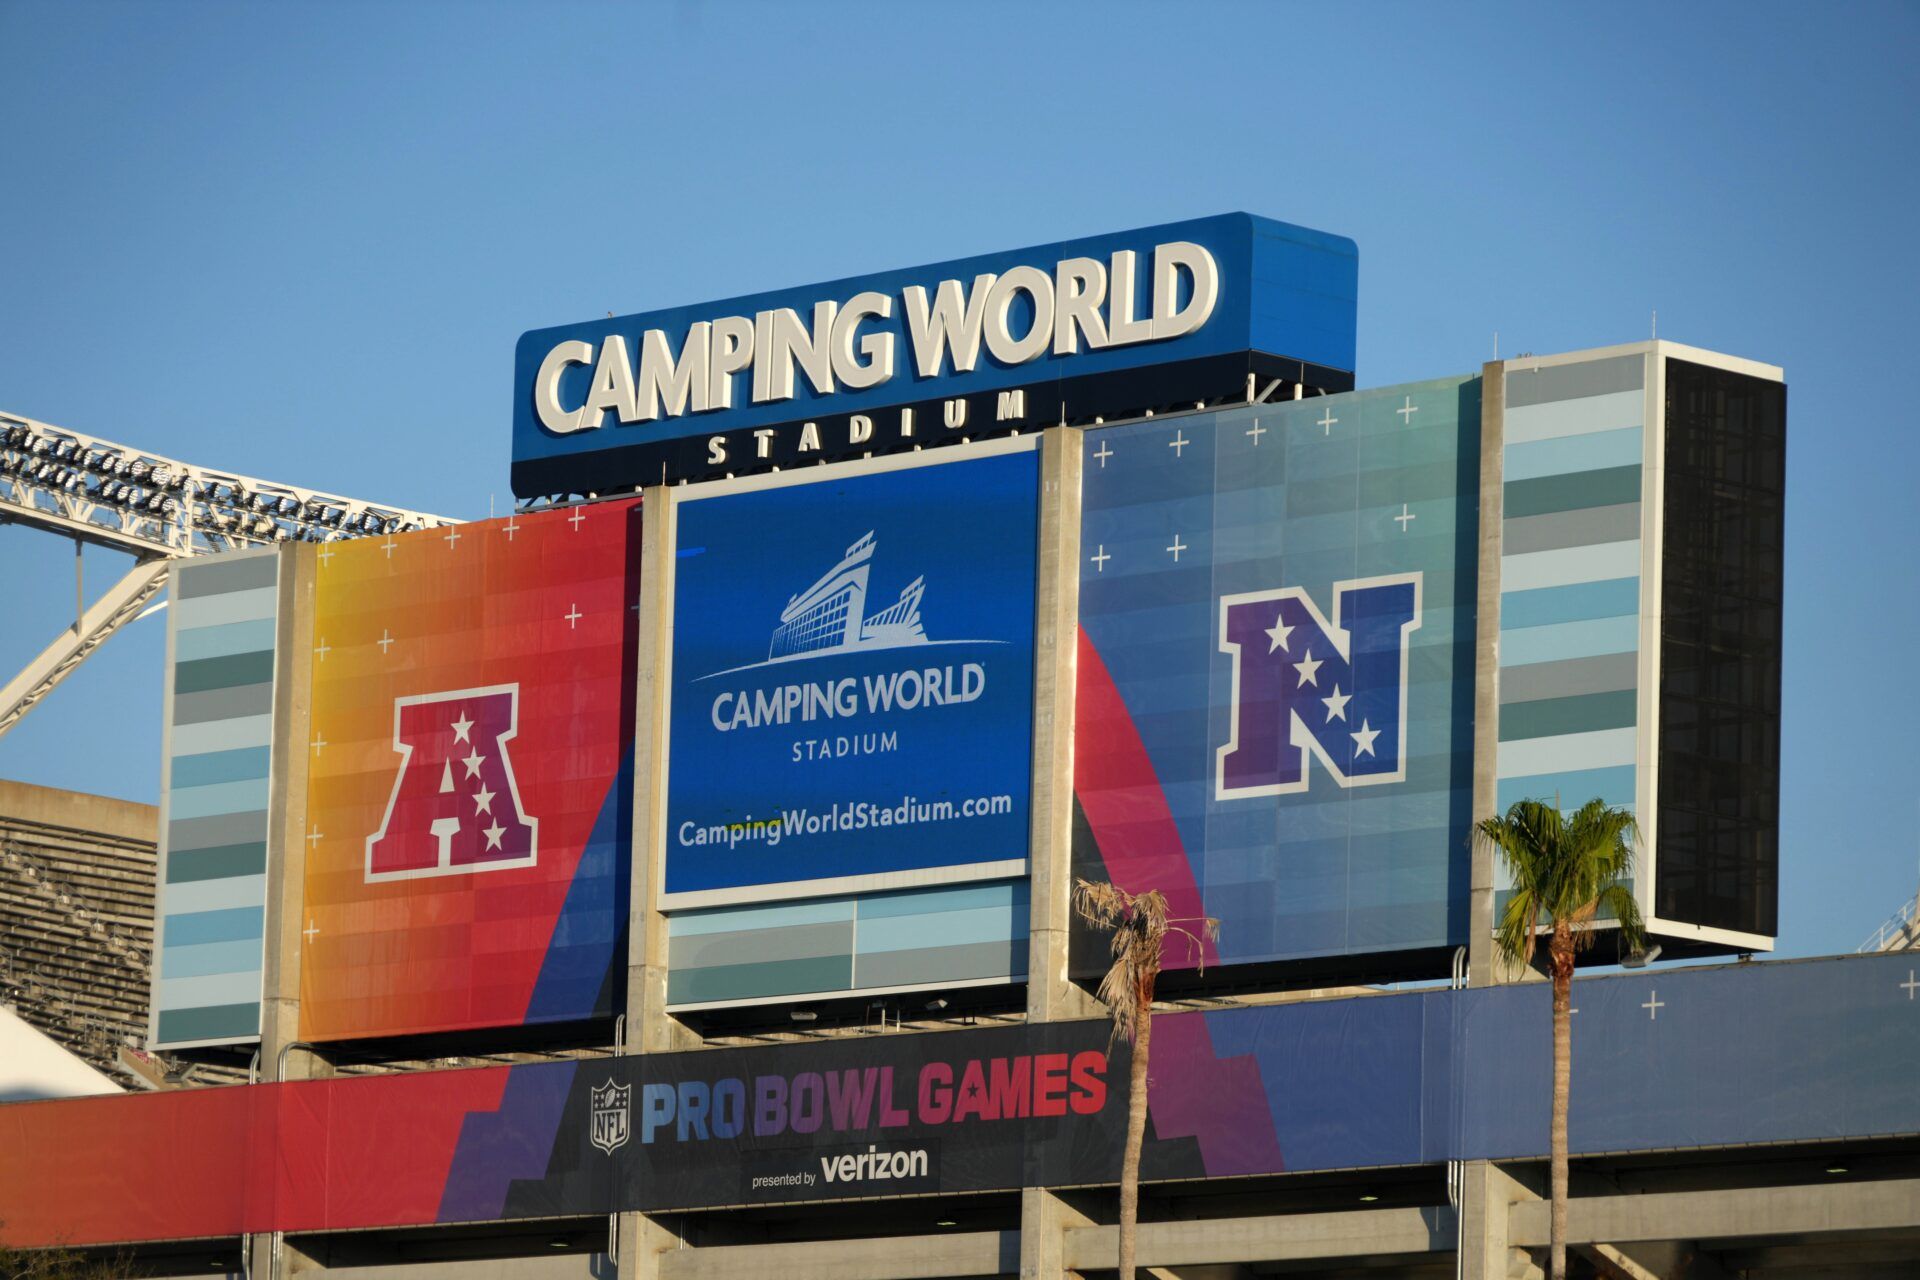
[1073,881,1219,1280]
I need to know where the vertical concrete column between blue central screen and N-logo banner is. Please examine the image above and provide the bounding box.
[1027,426,1098,1023]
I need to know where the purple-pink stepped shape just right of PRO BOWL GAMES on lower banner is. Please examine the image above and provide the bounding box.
[1146,1013,1286,1176]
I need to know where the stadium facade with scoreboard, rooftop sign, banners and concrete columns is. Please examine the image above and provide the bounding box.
[0,215,1920,1280]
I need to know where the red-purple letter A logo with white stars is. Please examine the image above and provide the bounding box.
[367,685,540,881]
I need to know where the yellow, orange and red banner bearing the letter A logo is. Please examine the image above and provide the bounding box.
[300,501,639,1040]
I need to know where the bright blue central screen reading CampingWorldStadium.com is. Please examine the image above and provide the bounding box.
[664,438,1039,908]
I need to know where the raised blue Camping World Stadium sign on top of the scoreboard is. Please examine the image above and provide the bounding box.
[513,213,1357,497]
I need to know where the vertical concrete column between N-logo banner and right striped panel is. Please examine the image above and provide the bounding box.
[1467,361,1507,986]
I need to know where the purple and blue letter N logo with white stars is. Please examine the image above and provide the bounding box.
[1213,574,1421,800]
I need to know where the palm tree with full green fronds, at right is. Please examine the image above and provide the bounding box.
[1476,798,1644,1280]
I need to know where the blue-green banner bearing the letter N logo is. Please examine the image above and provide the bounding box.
[1073,378,1480,975]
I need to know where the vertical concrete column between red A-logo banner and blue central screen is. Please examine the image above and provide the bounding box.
[626,486,699,1054]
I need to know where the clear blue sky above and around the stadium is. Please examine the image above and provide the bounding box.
[0,0,1920,956]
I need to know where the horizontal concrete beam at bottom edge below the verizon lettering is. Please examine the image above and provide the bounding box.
[660,1232,1020,1280]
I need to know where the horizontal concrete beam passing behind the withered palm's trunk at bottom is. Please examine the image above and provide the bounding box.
[1066,1207,1455,1270]
